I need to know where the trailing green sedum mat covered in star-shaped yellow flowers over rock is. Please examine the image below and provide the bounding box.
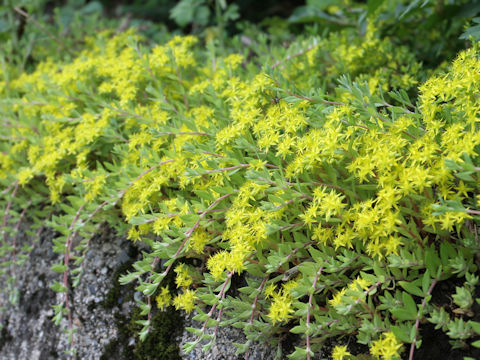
[0,1,480,360]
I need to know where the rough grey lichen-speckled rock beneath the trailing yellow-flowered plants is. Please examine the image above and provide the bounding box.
[0,226,273,360]
